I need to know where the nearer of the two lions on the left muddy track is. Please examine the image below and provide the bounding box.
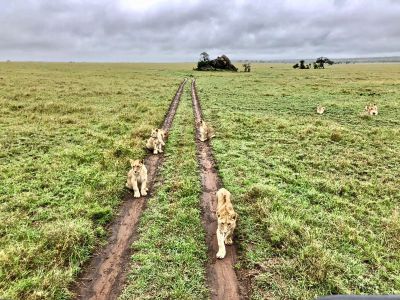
[126,159,148,198]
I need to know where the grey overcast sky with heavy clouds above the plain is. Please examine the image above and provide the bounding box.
[0,0,400,62]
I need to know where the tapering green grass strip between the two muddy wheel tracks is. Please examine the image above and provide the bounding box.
[120,84,208,300]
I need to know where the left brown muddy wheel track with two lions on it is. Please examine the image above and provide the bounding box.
[72,79,186,300]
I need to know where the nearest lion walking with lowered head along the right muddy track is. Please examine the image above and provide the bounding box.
[216,188,238,258]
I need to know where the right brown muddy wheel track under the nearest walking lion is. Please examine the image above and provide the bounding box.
[192,80,246,300]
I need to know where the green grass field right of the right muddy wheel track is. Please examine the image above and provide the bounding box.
[196,64,400,299]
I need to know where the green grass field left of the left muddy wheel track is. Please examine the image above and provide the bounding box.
[0,63,182,299]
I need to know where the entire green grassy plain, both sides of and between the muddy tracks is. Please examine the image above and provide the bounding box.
[0,62,400,299]
